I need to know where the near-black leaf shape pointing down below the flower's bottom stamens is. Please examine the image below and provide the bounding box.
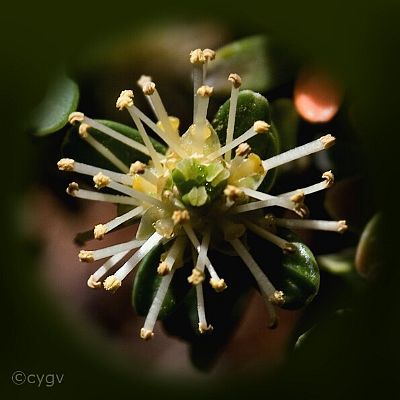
[163,251,253,370]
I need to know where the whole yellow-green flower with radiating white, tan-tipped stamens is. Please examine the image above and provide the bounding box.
[58,49,347,340]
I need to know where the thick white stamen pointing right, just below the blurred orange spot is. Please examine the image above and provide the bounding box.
[263,135,335,171]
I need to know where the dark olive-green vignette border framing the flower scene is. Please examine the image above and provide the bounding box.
[0,1,400,399]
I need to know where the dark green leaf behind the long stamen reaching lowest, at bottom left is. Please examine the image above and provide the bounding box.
[132,245,191,319]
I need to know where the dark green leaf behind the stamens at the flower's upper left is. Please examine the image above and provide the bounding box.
[62,120,166,170]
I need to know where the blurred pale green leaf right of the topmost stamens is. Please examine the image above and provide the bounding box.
[207,35,296,94]
